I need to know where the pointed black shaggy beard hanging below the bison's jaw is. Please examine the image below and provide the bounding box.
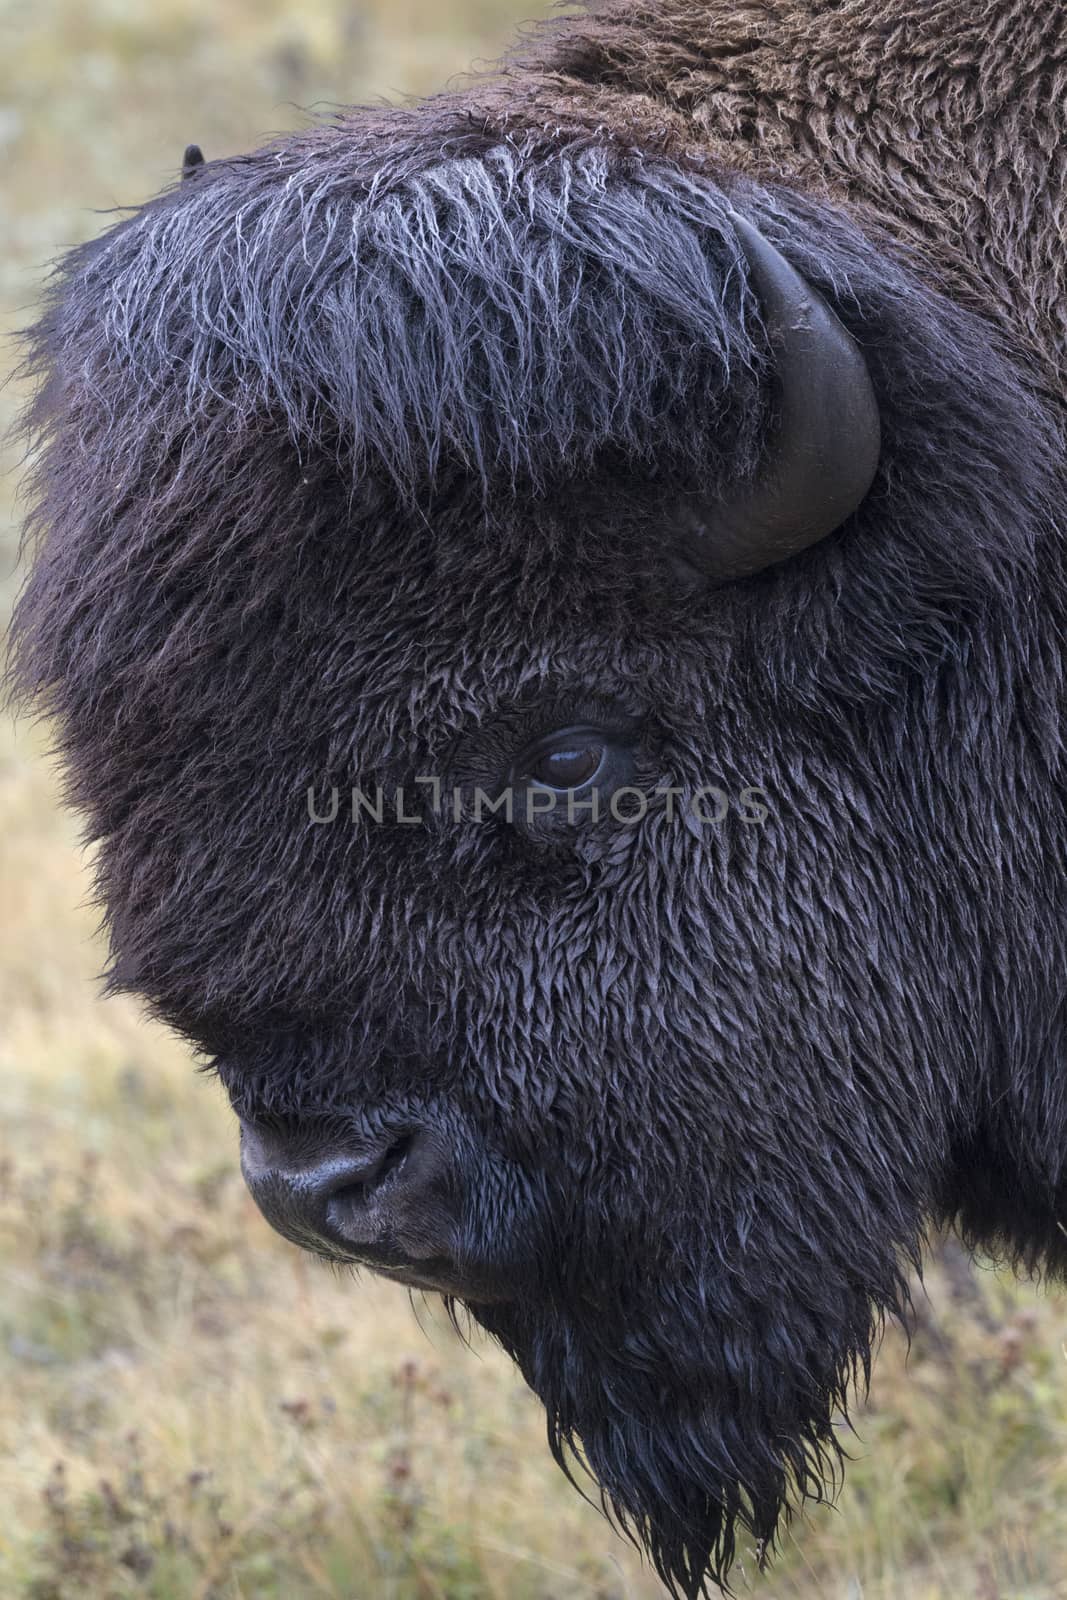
[472,1216,907,1600]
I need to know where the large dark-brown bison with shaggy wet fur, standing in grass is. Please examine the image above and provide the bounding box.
[14,0,1067,1597]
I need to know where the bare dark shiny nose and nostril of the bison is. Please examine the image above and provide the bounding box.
[242,1122,456,1286]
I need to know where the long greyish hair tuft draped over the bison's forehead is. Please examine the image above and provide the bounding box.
[69,136,760,494]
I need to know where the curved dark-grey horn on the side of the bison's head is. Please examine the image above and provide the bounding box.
[677,213,881,582]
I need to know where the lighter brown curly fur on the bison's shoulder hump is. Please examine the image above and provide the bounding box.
[502,0,1067,403]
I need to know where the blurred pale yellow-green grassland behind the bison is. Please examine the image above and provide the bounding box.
[0,0,1067,1600]
